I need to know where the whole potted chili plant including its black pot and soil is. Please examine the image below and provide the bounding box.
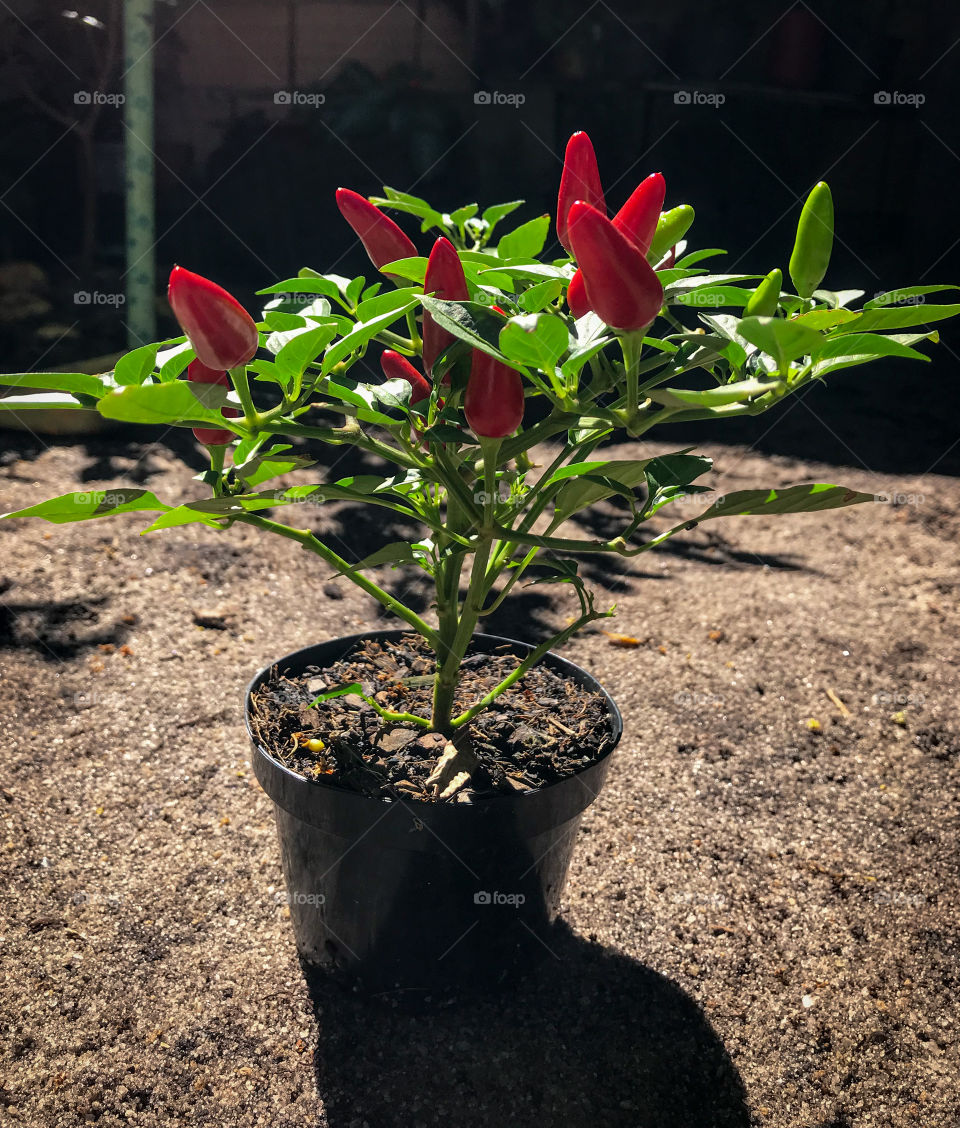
[0,133,960,995]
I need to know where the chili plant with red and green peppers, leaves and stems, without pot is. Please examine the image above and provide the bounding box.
[0,133,960,738]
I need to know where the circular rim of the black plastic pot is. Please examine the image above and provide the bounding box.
[244,627,624,811]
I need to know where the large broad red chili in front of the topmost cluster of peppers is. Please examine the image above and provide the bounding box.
[570,200,663,332]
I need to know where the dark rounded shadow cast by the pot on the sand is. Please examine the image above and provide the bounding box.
[305,922,750,1128]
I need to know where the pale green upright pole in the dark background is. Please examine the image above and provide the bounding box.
[123,0,157,349]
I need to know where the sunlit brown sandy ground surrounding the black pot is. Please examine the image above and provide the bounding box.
[0,424,960,1128]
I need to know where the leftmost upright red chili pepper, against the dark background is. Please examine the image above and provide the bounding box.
[167,266,259,370]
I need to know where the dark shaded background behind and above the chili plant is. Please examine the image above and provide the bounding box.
[0,0,960,474]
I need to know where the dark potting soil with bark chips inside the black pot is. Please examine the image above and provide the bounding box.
[250,634,613,802]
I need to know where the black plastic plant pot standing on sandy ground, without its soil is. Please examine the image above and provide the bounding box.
[246,631,623,1001]
